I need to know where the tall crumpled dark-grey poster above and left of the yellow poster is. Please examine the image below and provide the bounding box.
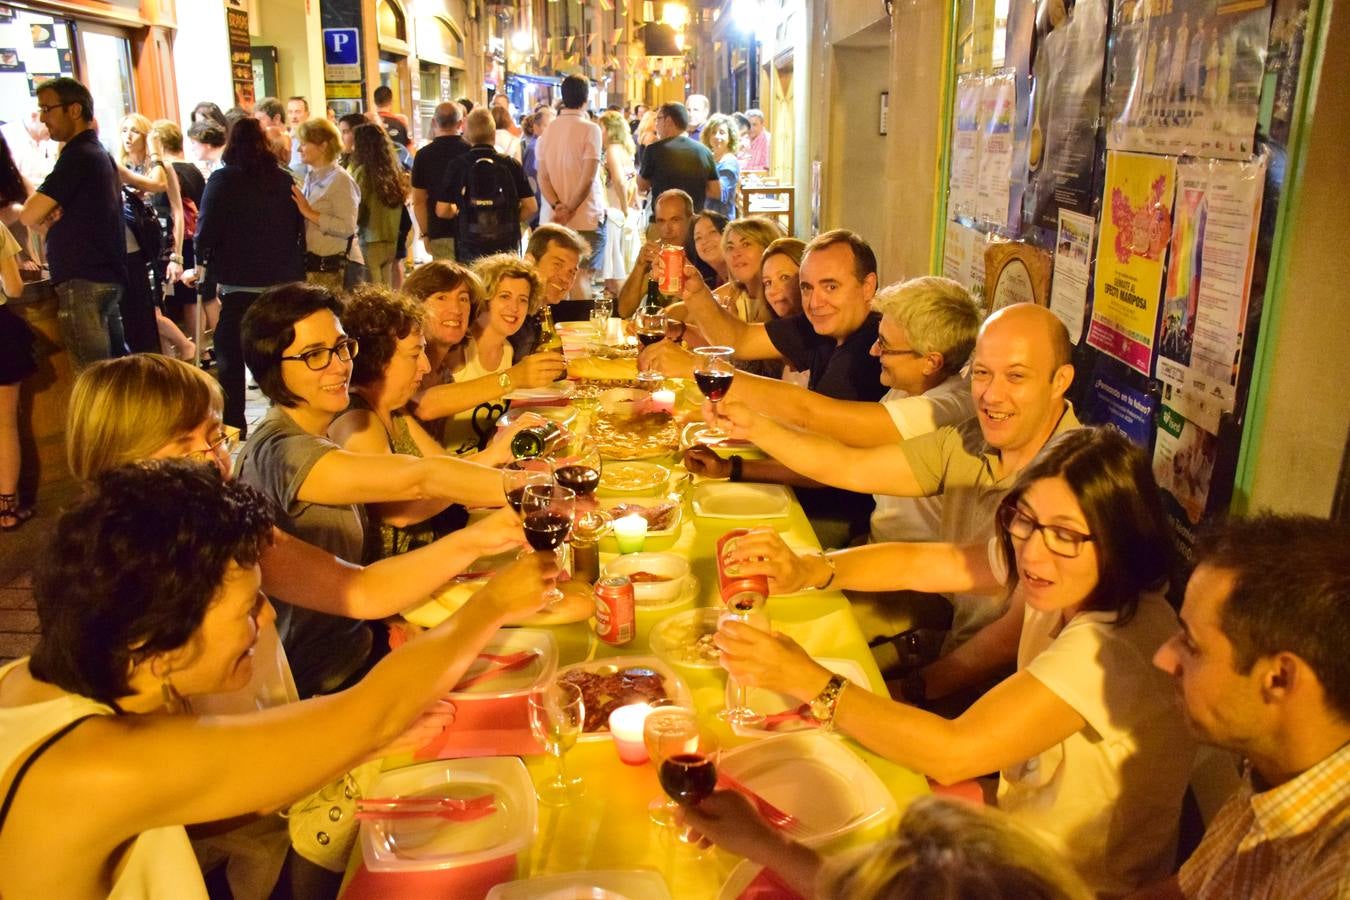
[1022,0,1107,232]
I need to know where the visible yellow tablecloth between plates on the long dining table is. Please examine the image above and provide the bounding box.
[343,356,929,900]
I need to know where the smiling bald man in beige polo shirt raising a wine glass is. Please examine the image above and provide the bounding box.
[721,304,1080,660]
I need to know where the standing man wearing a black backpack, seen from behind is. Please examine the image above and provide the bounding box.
[436,108,539,266]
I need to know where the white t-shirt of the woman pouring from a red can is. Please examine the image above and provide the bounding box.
[999,594,1195,895]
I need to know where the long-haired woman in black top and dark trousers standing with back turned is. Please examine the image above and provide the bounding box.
[193,119,305,432]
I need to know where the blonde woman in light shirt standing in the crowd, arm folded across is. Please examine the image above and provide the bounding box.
[292,119,362,290]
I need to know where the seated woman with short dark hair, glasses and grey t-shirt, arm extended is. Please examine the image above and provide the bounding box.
[239,283,506,696]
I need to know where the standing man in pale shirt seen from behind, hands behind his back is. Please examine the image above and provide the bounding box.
[535,76,605,300]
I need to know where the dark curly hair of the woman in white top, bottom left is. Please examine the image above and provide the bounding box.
[28,459,274,703]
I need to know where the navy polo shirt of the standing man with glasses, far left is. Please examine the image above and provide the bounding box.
[38,128,127,285]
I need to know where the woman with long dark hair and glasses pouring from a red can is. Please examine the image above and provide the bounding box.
[716,428,1195,896]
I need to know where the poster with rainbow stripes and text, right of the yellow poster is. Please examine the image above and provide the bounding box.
[1157,157,1265,434]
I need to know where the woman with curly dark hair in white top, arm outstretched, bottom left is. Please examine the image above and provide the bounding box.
[0,460,554,899]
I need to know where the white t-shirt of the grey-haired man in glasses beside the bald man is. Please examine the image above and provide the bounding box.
[872,375,975,544]
